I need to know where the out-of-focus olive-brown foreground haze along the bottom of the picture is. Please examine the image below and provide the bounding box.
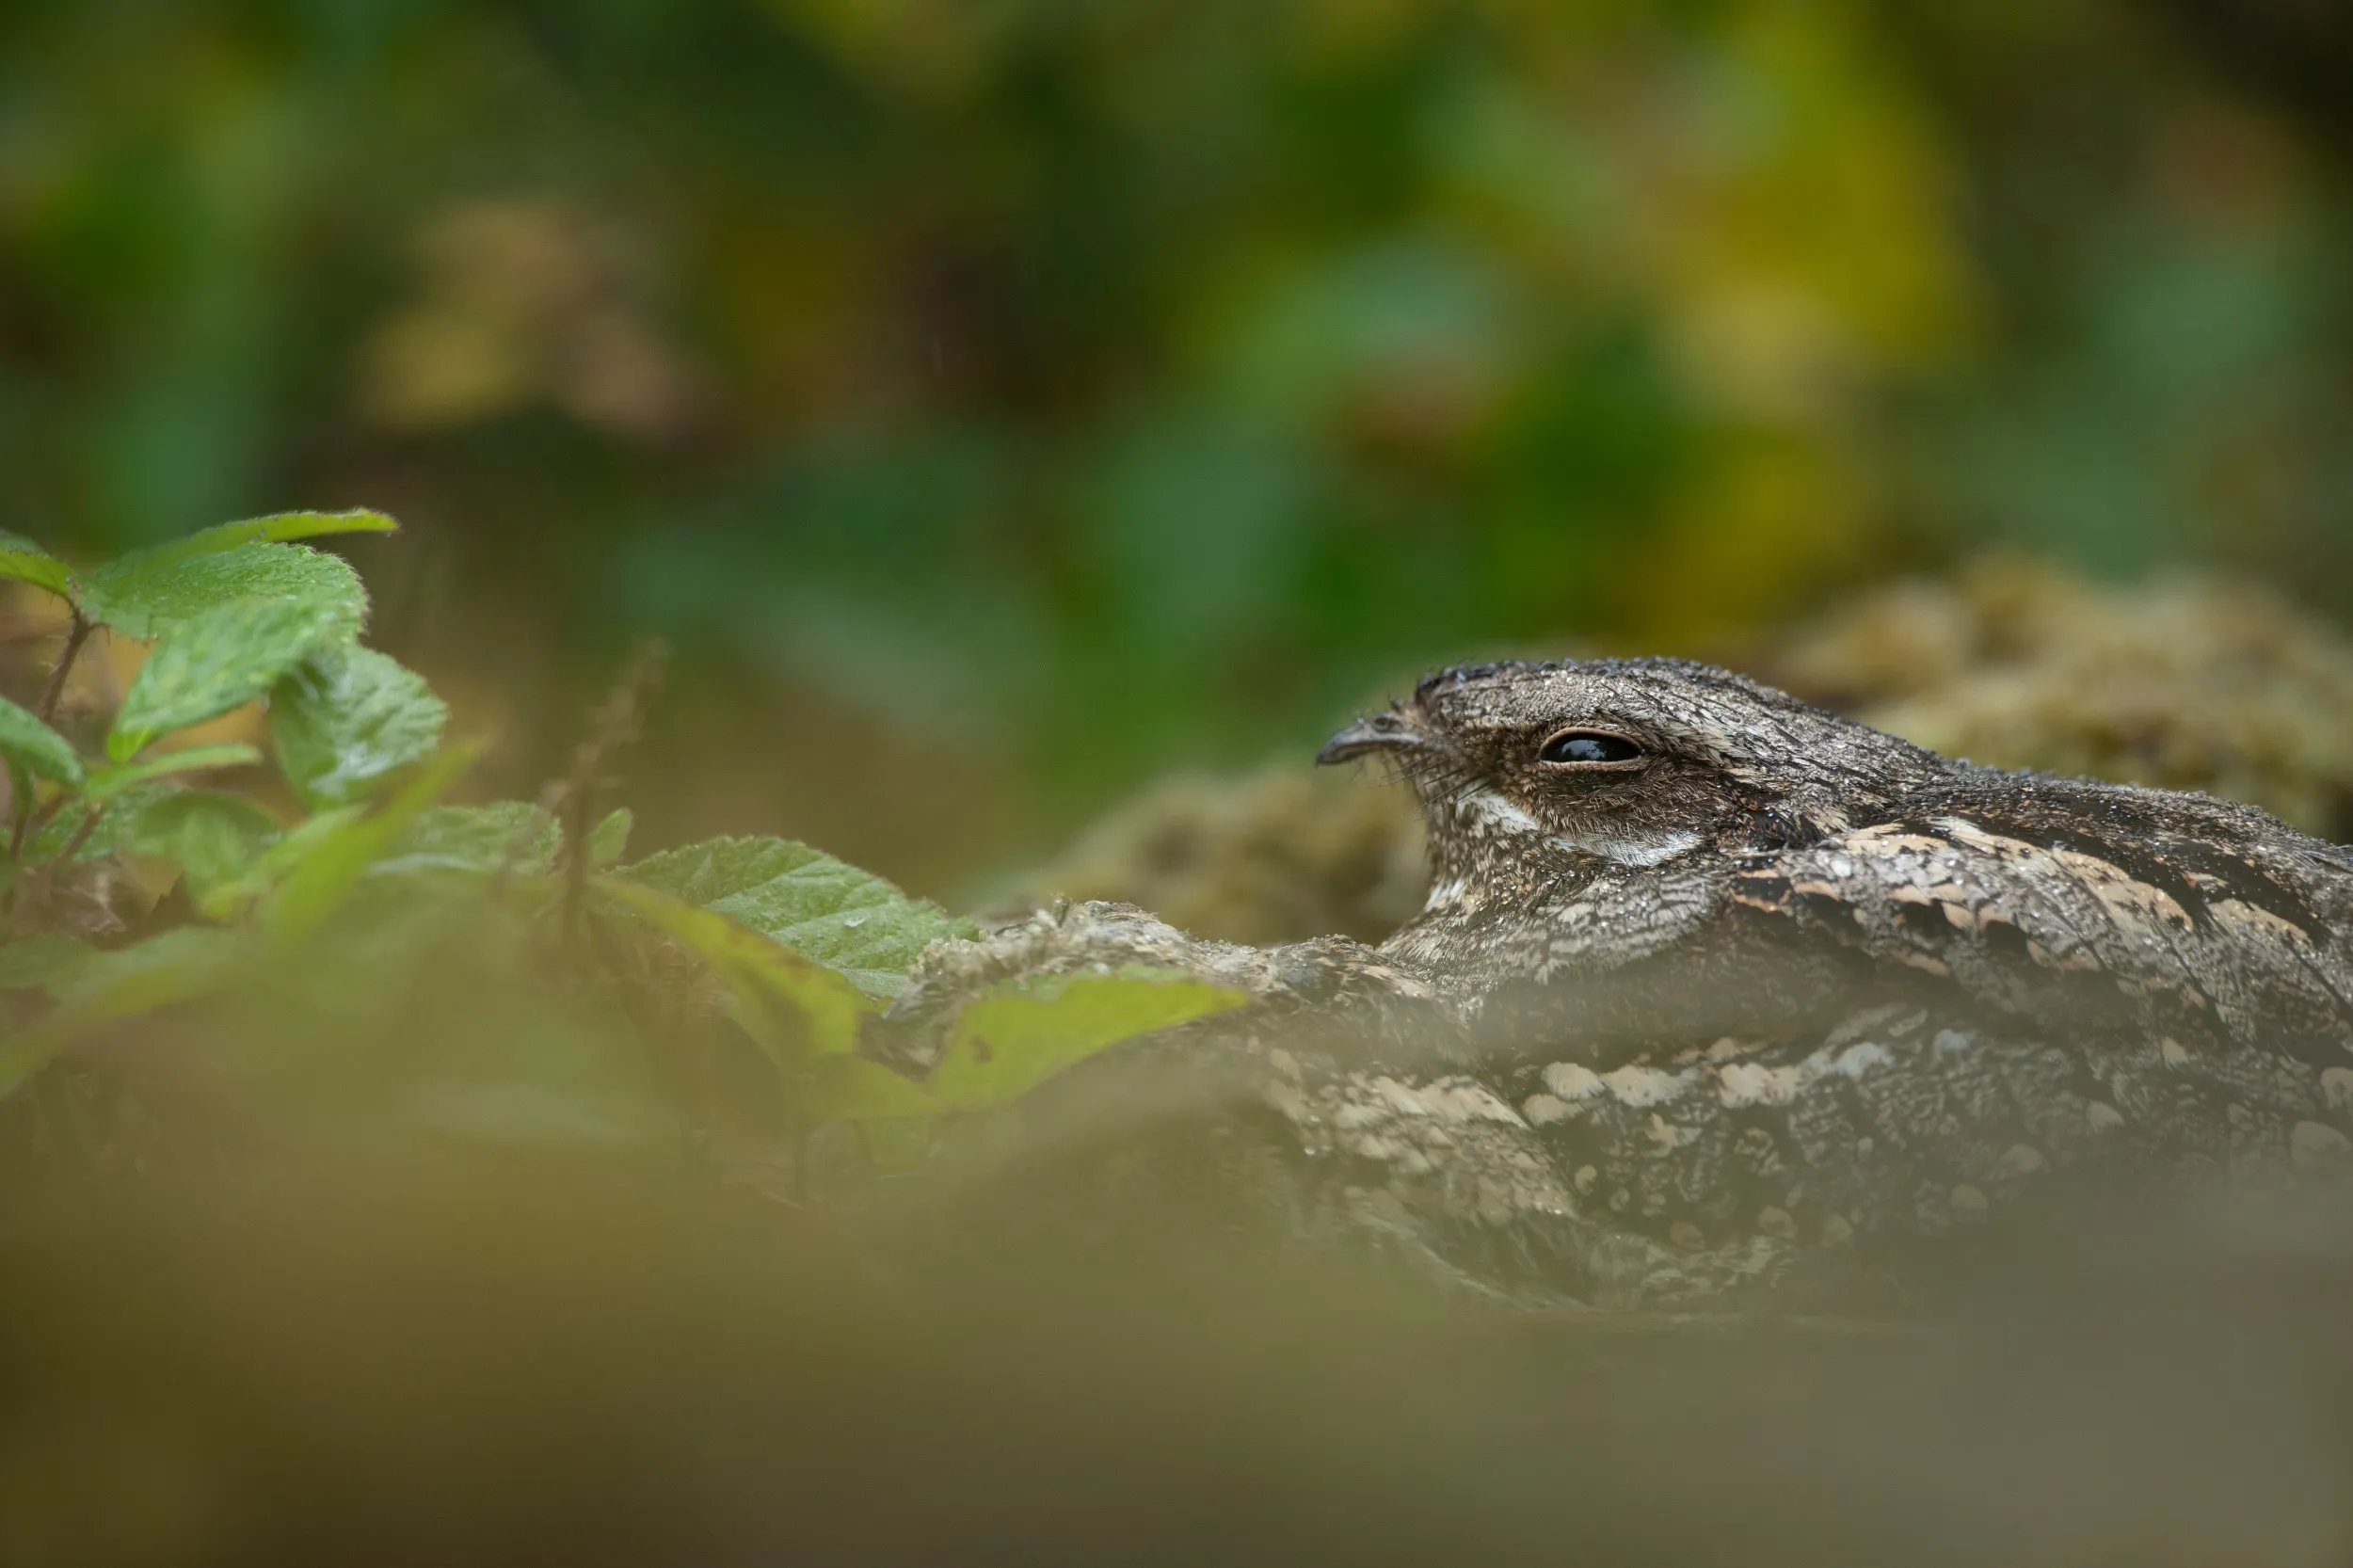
[0,1149,2353,1568]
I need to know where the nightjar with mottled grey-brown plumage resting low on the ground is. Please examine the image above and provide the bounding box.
[902,659,2353,1304]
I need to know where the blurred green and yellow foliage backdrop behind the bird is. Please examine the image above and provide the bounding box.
[0,0,2353,897]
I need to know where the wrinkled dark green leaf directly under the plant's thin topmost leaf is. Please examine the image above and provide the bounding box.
[75,535,367,643]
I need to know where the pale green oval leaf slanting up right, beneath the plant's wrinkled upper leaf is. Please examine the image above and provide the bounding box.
[106,595,342,762]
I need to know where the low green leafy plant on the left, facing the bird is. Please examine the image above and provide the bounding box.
[0,511,1242,1163]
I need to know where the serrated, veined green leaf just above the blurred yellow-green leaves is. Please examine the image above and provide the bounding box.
[621,839,977,996]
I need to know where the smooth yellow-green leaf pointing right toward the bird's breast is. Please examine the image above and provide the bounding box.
[930,966,1250,1112]
